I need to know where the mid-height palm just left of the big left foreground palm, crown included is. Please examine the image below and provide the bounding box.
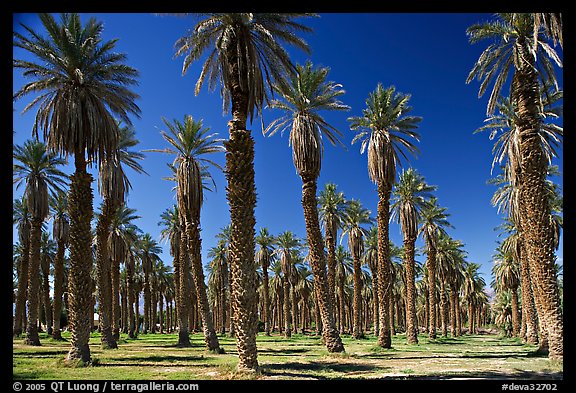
[12,140,68,345]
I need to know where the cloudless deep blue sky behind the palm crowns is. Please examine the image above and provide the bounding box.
[13,13,563,285]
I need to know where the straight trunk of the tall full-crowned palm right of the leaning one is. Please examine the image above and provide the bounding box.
[377,181,392,348]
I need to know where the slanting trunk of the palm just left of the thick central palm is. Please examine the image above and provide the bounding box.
[186,217,221,352]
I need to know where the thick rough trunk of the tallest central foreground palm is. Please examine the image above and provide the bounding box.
[224,128,259,371]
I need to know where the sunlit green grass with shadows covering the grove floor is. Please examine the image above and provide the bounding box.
[12,333,563,380]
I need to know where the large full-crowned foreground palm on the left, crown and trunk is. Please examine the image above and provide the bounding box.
[13,14,140,364]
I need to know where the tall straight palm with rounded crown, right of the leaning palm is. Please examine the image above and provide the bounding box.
[348,83,422,348]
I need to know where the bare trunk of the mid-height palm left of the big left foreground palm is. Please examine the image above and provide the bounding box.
[25,218,42,345]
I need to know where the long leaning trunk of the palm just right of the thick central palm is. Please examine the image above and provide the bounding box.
[302,176,344,352]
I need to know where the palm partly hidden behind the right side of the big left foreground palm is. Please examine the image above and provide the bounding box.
[96,121,146,348]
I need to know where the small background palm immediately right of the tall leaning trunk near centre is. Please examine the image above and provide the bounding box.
[318,183,347,316]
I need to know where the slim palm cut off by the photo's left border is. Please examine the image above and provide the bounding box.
[12,195,32,337]
